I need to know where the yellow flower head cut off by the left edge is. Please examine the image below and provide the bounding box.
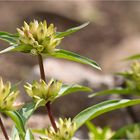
[0,78,19,111]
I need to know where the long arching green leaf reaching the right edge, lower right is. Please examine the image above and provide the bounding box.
[73,99,140,129]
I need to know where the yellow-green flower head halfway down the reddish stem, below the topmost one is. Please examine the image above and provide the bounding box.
[24,79,62,102]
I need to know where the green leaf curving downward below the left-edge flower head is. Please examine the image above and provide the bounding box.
[4,111,25,138]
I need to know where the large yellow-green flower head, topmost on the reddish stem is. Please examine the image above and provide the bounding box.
[17,20,62,54]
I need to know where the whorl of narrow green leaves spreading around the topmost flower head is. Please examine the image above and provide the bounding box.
[0,22,101,70]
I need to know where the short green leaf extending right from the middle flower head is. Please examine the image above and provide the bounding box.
[57,85,92,98]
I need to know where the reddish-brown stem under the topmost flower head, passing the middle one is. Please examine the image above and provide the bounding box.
[38,54,57,132]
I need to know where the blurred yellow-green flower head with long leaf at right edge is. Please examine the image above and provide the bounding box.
[89,61,140,97]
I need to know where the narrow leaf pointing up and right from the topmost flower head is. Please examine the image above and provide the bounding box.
[56,22,89,38]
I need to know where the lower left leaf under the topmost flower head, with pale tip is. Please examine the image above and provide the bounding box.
[0,45,32,54]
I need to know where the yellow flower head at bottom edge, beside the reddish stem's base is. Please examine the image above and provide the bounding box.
[41,118,76,140]
